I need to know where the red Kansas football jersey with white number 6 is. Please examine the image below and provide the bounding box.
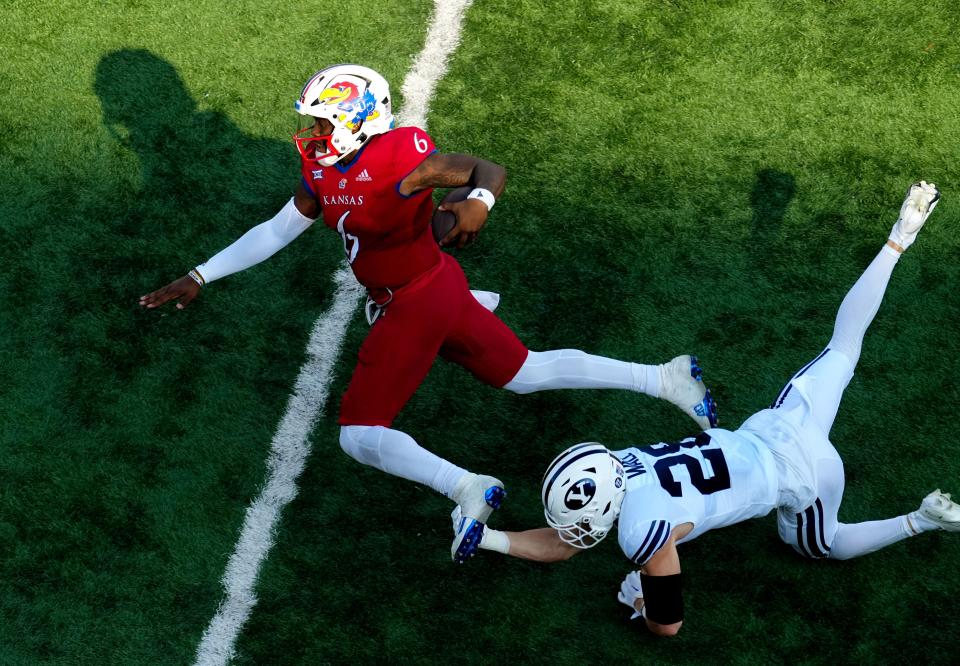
[302,127,441,288]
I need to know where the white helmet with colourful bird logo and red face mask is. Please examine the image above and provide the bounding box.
[293,65,396,166]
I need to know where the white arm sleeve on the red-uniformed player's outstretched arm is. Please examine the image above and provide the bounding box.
[196,197,314,282]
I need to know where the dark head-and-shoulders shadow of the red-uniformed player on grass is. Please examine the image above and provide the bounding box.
[94,49,296,252]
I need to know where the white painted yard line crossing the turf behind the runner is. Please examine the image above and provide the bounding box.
[194,0,472,666]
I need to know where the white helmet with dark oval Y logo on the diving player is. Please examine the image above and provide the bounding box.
[542,442,627,548]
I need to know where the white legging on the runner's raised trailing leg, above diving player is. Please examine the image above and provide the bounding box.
[503,349,660,398]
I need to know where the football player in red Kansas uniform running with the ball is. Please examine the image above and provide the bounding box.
[140,65,716,562]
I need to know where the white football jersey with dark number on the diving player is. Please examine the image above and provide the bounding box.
[613,428,778,565]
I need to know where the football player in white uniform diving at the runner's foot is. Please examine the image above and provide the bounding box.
[464,182,960,636]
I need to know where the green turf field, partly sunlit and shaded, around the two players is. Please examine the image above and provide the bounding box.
[0,0,960,666]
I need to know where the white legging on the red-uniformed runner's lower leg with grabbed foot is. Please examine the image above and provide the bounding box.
[340,426,467,497]
